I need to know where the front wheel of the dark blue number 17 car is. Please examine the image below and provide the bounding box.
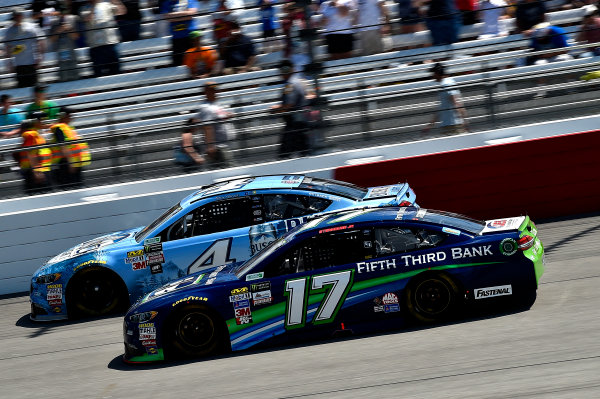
[163,305,225,359]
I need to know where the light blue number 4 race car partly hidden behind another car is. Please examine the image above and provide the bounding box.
[30,175,415,320]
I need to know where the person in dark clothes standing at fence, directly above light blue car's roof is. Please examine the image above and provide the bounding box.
[271,60,309,159]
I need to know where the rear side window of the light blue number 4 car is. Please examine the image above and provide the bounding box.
[264,194,332,221]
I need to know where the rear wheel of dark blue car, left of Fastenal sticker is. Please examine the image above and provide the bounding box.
[405,272,459,323]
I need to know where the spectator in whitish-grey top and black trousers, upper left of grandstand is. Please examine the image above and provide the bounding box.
[80,0,127,78]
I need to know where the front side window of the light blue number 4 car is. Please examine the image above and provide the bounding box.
[161,197,254,241]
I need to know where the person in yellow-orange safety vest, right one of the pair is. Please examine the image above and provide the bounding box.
[50,106,91,187]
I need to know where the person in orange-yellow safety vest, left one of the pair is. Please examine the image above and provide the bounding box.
[18,119,52,194]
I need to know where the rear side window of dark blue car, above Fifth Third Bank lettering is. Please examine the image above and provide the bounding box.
[374,227,446,257]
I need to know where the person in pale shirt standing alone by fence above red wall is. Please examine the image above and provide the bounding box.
[424,62,469,134]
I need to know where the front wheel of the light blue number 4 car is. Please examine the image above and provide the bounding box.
[66,266,129,318]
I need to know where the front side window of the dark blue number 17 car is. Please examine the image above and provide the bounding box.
[265,229,370,277]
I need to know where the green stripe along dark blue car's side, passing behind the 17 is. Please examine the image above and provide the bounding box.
[226,262,505,334]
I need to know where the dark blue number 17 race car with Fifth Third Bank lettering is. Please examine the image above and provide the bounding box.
[123,207,544,362]
